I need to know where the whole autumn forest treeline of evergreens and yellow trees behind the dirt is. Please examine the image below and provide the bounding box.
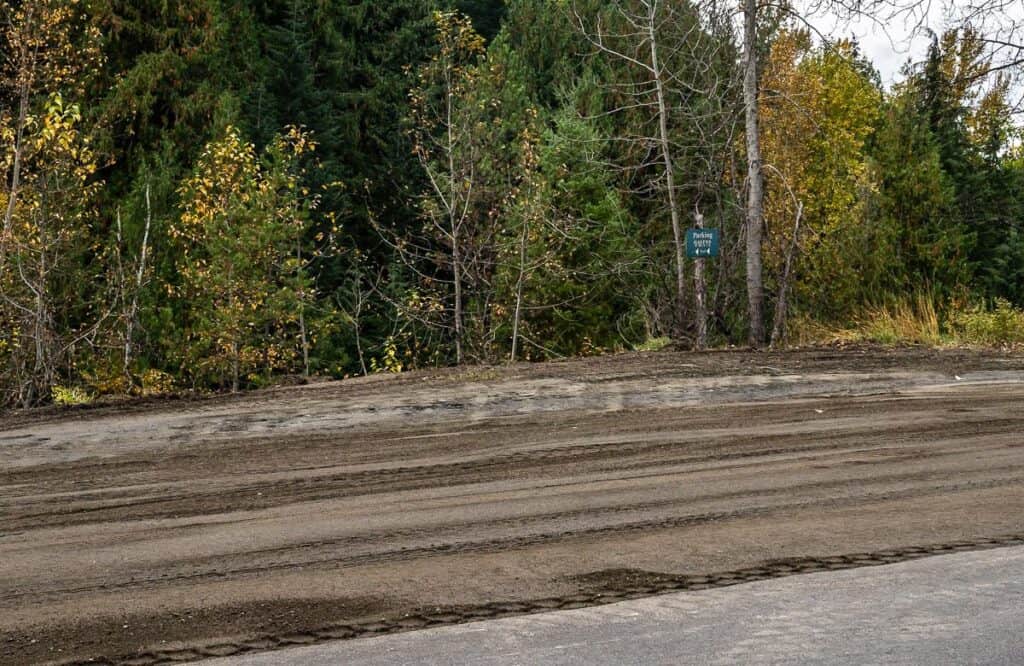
[0,0,1024,406]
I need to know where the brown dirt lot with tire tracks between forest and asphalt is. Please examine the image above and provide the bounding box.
[0,348,1024,664]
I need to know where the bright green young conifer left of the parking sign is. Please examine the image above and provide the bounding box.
[497,107,644,358]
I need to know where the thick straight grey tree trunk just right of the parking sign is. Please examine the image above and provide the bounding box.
[743,0,765,348]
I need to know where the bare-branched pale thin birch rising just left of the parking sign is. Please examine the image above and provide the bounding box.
[573,0,734,346]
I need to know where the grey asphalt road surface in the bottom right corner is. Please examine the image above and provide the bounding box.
[204,547,1024,666]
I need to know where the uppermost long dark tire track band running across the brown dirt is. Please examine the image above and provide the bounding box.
[6,403,1024,532]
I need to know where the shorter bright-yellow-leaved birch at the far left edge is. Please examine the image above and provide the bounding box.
[0,94,102,407]
